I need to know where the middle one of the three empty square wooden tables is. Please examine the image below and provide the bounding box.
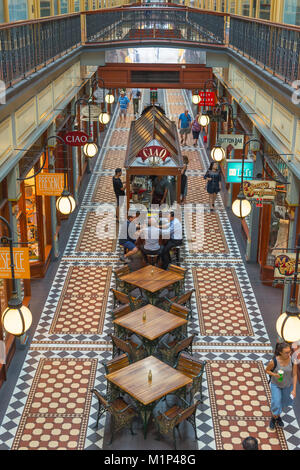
[114,304,187,355]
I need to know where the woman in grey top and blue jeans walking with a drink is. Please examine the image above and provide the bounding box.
[266,343,297,429]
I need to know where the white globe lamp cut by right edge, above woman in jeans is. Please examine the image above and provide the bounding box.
[276,300,300,343]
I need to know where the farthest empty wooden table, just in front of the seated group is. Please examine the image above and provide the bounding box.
[120,265,184,304]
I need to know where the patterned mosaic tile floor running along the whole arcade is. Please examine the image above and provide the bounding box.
[0,90,300,450]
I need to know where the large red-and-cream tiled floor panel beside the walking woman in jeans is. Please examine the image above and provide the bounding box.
[206,361,287,450]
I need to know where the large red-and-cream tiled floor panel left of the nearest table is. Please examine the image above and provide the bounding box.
[12,359,97,450]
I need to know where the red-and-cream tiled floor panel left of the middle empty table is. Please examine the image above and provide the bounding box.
[50,266,112,334]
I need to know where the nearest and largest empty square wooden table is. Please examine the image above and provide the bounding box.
[106,356,192,439]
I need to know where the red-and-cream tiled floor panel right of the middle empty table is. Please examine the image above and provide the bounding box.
[193,267,254,336]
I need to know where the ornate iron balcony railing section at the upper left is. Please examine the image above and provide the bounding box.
[0,15,81,86]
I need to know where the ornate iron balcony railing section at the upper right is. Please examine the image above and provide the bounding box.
[229,16,300,83]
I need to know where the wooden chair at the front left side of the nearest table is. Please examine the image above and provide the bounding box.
[91,388,137,445]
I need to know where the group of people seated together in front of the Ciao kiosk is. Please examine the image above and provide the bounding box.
[119,211,182,269]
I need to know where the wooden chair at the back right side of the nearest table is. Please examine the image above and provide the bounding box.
[175,352,206,402]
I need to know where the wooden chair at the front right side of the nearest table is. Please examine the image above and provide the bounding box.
[155,399,200,450]
